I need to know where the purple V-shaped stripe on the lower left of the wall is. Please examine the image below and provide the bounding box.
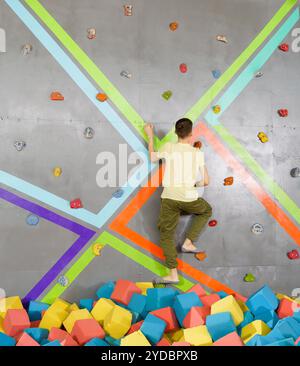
[0,188,96,305]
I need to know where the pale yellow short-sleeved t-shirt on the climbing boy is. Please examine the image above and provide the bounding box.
[156,142,204,202]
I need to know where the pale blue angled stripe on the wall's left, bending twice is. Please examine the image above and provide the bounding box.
[0,0,155,228]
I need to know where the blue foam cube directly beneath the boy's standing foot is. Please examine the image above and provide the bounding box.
[145,288,178,312]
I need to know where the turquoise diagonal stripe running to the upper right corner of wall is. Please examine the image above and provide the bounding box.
[205,7,300,126]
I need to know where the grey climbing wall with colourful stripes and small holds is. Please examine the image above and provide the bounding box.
[0,0,300,303]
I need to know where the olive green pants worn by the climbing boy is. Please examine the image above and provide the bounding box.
[158,198,212,269]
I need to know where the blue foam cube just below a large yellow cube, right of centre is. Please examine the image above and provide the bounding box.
[206,312,236,342]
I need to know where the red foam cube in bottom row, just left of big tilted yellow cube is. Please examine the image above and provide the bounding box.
[71,319,105,346]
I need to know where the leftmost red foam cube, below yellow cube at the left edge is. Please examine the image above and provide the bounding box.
[3,309,30,337]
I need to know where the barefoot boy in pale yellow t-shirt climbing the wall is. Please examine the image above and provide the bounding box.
[145,118,212,284]
